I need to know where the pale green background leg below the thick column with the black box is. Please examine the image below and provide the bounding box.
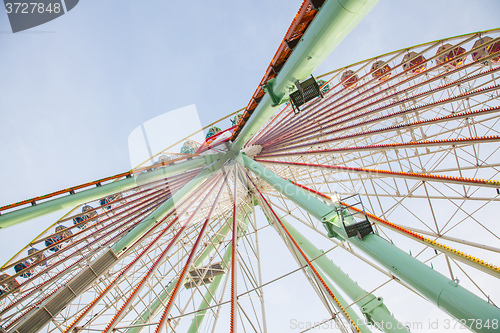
[280,213,409,333]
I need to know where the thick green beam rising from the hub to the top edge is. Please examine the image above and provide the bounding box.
[231,0,378,152]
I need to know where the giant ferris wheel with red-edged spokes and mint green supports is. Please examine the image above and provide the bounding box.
[0,1,500,333]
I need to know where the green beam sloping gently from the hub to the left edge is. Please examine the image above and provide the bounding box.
[0,155,219,229]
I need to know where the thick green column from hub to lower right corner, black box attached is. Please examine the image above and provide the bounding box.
[243,156,500,333]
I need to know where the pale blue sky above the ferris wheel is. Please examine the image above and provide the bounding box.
[0,0,500,330]
